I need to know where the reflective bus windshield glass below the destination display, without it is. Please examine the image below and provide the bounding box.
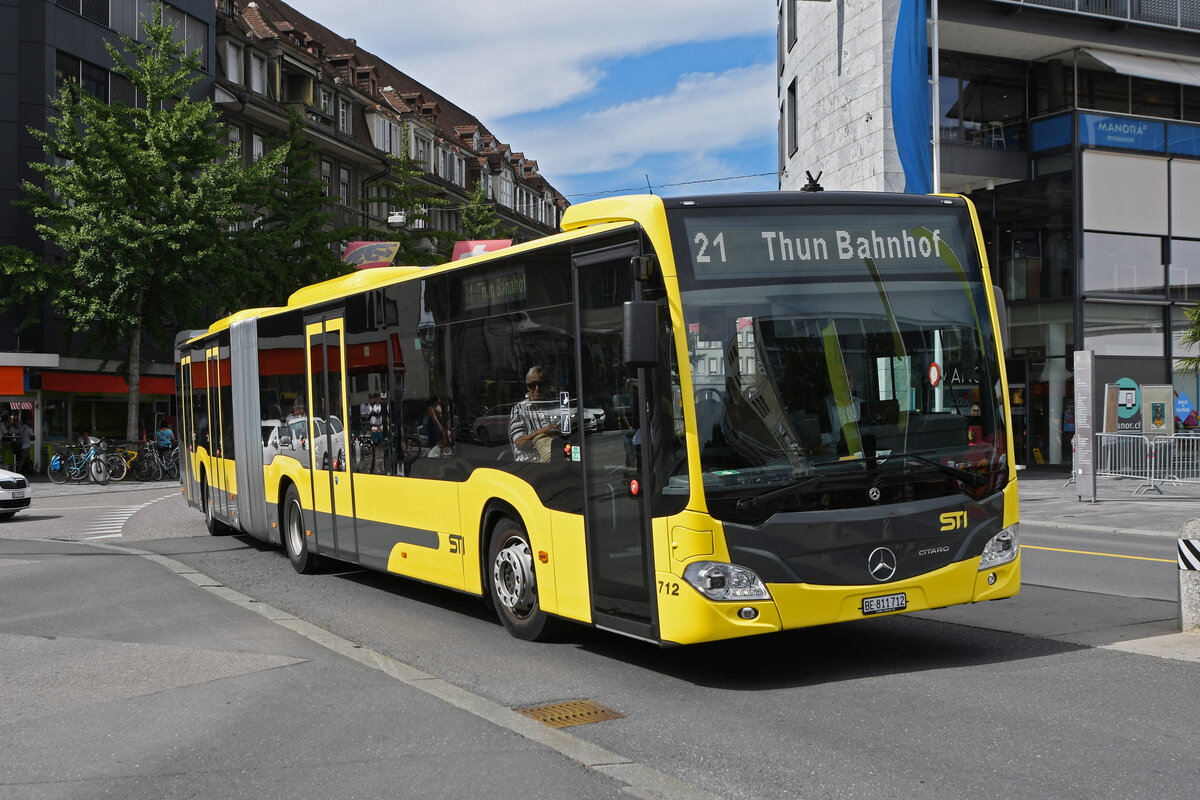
[684,272,1006,513]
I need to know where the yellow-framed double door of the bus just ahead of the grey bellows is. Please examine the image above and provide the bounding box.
[305,317,359,561]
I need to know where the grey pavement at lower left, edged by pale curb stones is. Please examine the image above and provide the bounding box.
[0,532,681,800]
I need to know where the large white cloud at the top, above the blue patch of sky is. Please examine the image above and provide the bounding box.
[280,0,776,118]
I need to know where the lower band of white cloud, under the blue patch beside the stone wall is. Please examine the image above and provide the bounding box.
[505,64,776,175]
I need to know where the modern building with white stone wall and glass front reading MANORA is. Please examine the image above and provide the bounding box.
[778,0,1200,464]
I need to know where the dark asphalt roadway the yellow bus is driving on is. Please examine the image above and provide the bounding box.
[0,474,1200,800]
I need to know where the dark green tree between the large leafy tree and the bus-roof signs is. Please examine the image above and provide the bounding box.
[233,113,359,306]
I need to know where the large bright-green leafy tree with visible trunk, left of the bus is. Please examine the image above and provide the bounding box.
[12,5,278,439]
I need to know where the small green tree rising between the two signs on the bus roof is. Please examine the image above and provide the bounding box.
[361,125,456,266]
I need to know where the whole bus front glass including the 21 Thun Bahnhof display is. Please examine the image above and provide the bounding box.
[673,205,1007,518]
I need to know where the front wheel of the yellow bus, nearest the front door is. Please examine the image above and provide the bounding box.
[487,517,556,642]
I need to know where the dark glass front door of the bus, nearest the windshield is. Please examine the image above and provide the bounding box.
[574,242,656,638]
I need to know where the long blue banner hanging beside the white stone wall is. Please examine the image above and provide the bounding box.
[892,0,934,194]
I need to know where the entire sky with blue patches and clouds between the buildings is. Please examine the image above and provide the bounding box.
[287,0,779,203]
